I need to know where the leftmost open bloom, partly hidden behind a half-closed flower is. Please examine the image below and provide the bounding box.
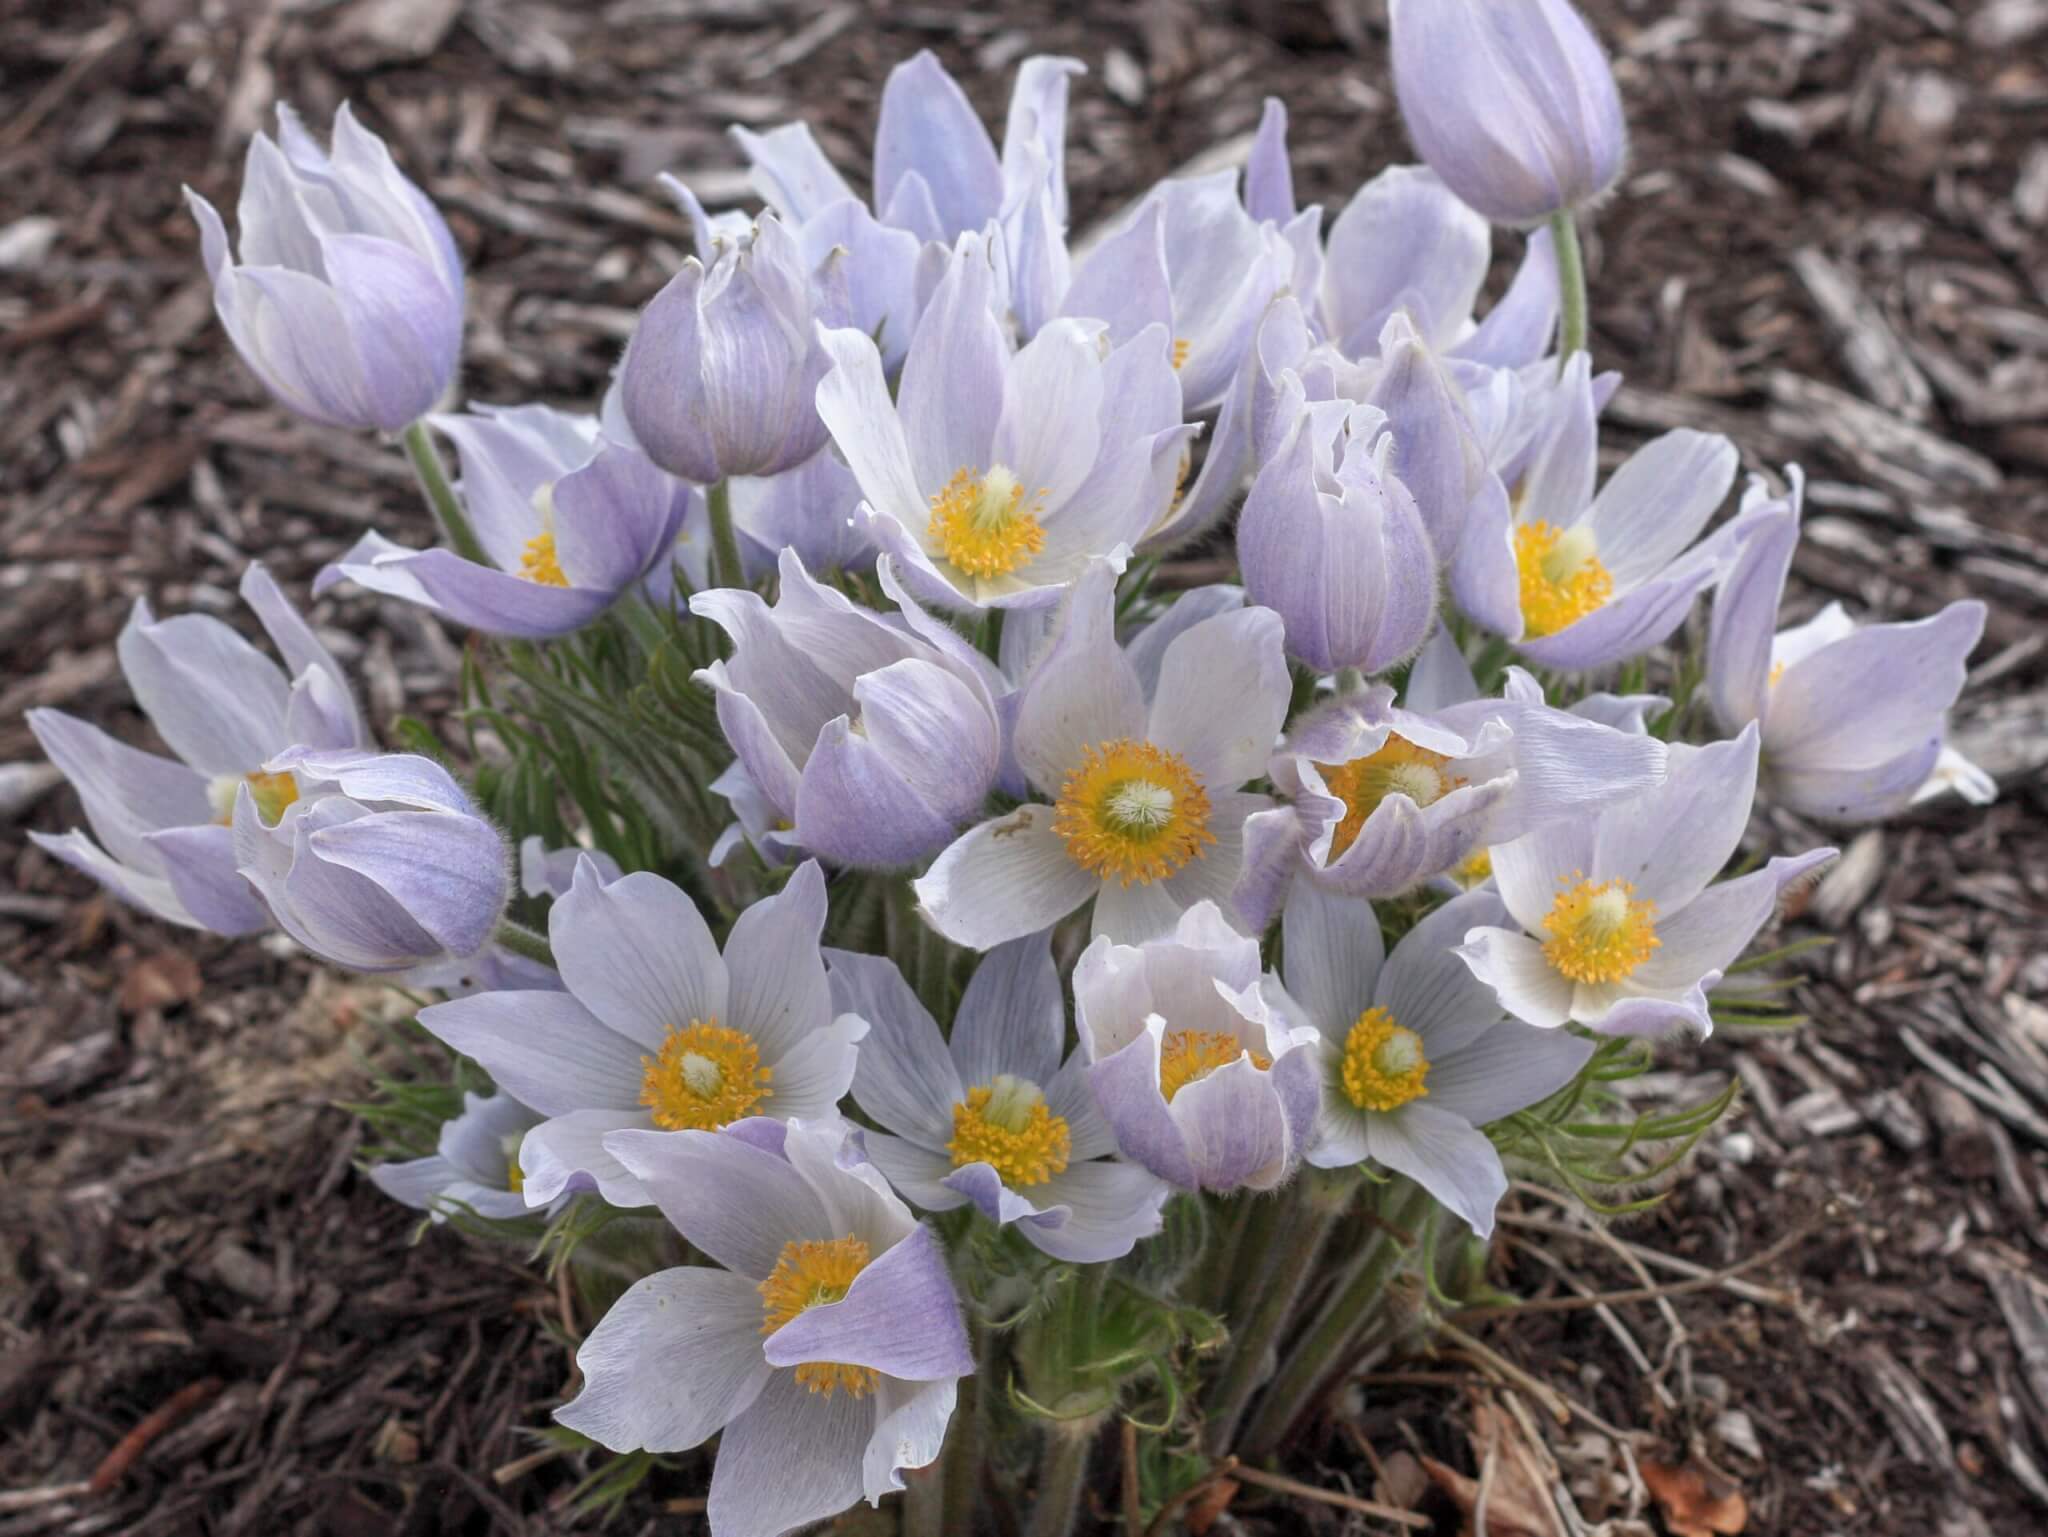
[29,566,369,934]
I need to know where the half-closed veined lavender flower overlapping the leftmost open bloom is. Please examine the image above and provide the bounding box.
[231,748,512,978]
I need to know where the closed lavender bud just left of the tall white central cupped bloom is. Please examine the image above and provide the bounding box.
[618,213,848,486]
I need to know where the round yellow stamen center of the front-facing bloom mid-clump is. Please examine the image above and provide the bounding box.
[1053,738,1217,885]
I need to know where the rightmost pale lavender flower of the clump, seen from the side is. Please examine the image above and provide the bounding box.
[1706,465,1997,822]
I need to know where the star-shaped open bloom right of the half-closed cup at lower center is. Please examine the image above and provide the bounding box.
[1284,881,1593,1238]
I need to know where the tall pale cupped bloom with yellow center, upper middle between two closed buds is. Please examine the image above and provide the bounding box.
[817,236,1194,611]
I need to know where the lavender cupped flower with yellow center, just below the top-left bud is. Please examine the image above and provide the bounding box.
[313,406,694,637]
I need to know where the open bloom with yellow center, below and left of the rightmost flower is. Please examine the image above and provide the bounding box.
[1458,725,1835,1035]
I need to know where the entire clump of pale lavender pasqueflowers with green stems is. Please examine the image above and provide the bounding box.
[31,0,1993,1537]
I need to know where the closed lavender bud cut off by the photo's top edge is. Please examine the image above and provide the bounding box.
[1391,0,1628,223]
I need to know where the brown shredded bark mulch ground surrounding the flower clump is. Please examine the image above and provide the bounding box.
[0,0,2048,1537]
